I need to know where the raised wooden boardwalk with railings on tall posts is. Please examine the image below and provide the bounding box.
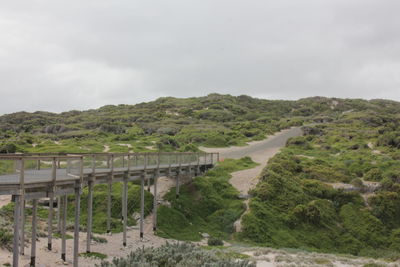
[0,153,219,266]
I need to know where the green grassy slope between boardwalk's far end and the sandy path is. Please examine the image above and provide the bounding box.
[157,157,256,241]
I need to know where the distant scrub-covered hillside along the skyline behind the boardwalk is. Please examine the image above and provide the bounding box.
[0,94,400,153]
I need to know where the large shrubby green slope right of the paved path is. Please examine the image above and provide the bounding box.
[241,112,400,257]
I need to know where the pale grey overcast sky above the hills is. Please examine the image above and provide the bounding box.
[0,0,400,114]
